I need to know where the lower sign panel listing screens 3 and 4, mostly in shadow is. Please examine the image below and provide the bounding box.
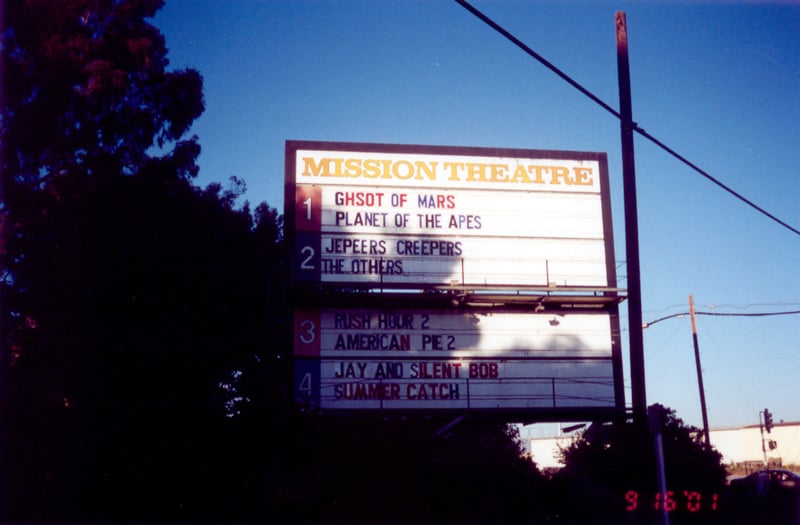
[294,308,618,410]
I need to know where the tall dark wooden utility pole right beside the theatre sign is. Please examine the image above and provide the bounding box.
[615,11,647,423]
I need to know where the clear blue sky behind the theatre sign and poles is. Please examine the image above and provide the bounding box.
[155,0,800,428]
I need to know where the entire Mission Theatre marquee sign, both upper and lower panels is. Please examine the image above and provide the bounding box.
[285,141,624,421]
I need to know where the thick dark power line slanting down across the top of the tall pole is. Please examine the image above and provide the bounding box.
[455,0,800,235]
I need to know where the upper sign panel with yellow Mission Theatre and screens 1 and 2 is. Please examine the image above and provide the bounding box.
[286,141,615,288]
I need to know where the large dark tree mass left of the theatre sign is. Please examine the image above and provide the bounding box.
[0,0,283,521]
